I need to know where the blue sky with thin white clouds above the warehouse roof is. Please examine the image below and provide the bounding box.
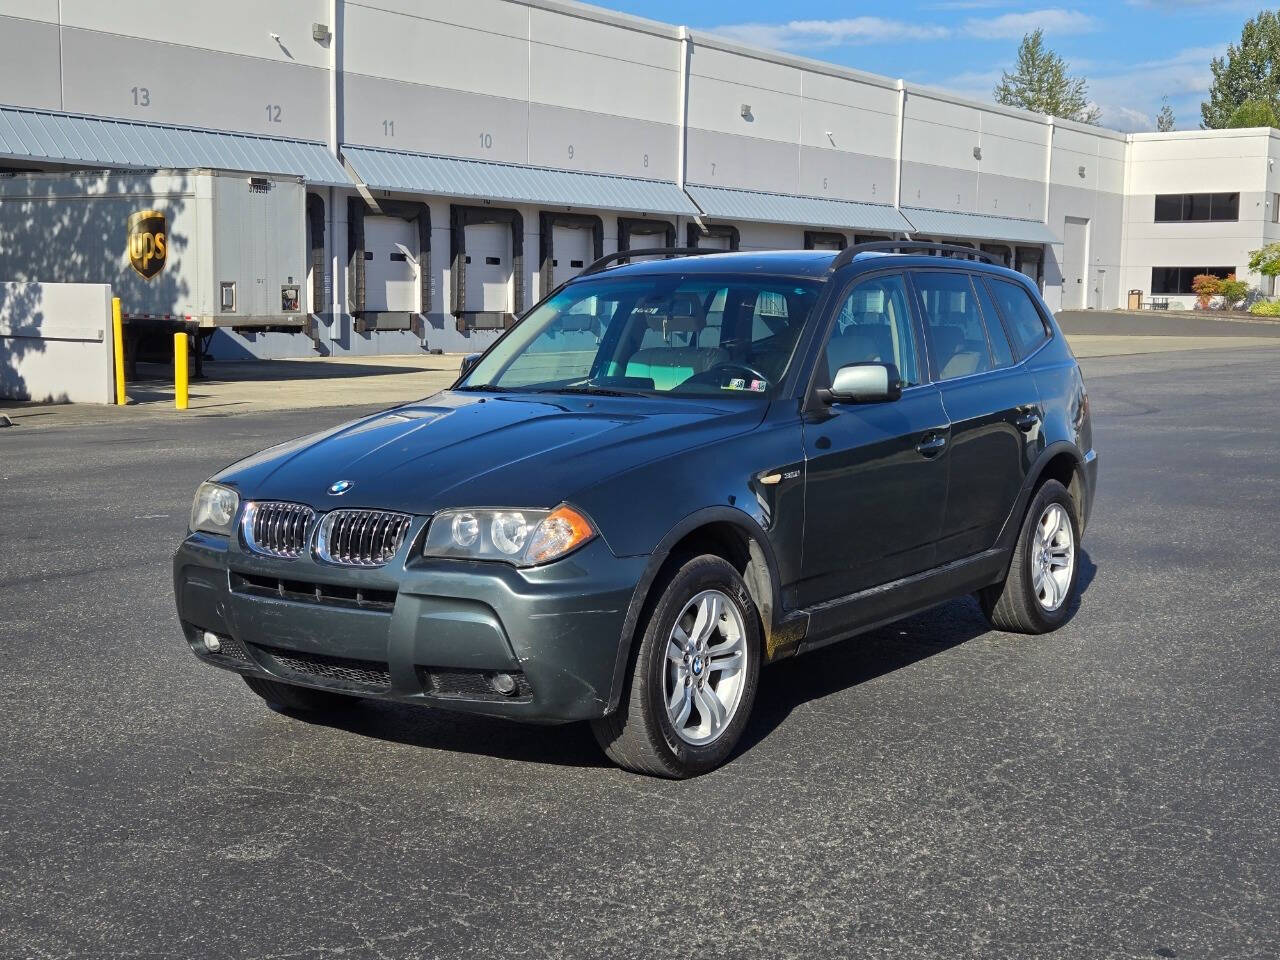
[595,0,1260,131]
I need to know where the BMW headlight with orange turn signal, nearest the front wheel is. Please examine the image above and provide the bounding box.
[422,504,595,567]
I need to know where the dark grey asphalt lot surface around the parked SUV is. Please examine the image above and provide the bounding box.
[0,349,1280,960]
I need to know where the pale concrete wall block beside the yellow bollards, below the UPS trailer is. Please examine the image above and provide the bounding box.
[0,283,115,403]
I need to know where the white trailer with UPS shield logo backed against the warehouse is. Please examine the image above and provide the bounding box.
[0,169,308,337]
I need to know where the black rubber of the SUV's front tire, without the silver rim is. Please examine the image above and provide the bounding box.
[591,554,764,780]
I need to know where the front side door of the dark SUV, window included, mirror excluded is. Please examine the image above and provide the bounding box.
[797,274,948,607]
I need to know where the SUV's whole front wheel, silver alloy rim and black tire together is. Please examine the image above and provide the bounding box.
[591,554,763,780]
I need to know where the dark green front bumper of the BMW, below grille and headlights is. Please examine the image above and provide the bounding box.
[173,534,645,722]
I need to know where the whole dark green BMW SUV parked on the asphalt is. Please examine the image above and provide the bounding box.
[174,242,1097,777]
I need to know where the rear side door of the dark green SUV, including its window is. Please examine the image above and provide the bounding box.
[913,270,1041,564]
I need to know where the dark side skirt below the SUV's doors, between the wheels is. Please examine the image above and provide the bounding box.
[797,548,1010,653]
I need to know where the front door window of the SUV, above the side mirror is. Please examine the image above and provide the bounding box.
[826,274,920,387]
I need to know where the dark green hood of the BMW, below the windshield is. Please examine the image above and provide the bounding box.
[214,392,764,515]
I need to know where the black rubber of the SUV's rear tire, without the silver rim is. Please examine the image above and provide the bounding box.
[978,480,1080,634]
